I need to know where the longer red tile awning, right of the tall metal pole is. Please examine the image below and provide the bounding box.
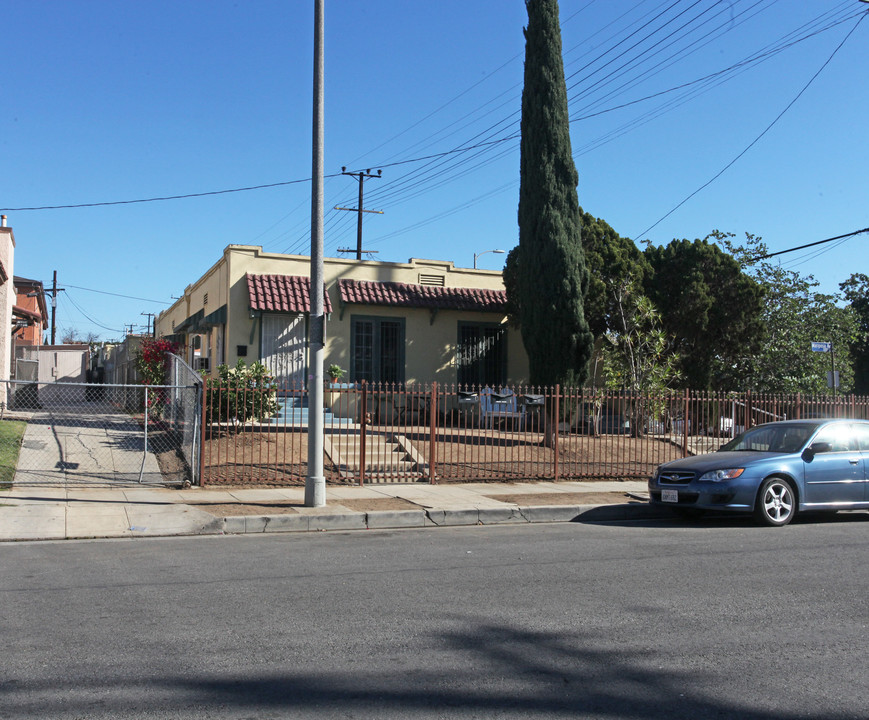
[338,280,507,313]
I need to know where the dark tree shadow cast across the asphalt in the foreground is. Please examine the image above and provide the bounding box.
[0,618,842,720]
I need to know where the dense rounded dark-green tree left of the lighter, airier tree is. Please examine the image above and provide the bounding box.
[644,239,763,390]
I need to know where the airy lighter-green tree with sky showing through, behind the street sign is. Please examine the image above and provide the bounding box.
[712,231,854,394]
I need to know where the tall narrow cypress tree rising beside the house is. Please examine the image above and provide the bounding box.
[515,0,593,386]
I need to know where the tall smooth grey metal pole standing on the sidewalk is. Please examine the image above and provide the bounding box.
[305,0,326,507]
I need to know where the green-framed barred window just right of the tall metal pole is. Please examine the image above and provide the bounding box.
[350,317,404,383]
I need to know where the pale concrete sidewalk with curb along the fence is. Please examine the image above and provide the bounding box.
[0,481,662,541]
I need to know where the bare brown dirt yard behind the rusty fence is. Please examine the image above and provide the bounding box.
[192,428,682,487]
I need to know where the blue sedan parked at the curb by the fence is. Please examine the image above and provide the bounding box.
[649,420,869,526]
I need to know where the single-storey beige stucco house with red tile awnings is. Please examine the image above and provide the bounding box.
[155,245,528,386]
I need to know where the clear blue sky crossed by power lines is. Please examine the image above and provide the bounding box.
[0,0,869,339]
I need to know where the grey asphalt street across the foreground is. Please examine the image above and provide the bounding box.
[0,513,869,720]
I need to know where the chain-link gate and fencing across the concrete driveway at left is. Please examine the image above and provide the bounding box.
[0,371,202,487]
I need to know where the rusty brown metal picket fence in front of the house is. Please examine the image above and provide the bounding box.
[200,383,869,486]
